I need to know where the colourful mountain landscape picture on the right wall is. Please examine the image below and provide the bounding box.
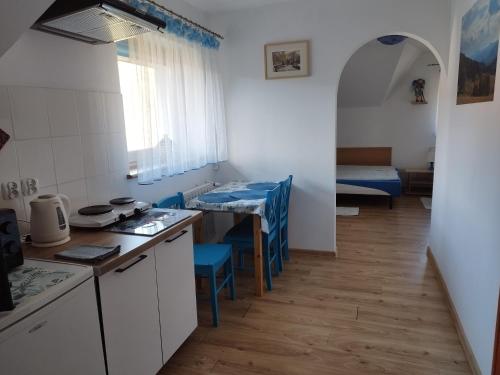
[457,0,500,105]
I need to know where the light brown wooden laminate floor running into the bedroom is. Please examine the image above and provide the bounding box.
[161,197,470,375]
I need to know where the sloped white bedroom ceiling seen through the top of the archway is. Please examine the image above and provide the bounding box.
[338,39,427,108]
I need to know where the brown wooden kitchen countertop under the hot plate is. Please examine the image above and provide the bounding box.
[23,211,203,276]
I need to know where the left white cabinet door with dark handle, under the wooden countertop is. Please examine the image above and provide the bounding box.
[99,249,162,375]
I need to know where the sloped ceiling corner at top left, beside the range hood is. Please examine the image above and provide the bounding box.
[0,0,54,57]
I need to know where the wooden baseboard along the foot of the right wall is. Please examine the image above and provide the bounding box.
[427,246,482,375]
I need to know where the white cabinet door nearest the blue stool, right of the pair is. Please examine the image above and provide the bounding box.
[155,226,198,363]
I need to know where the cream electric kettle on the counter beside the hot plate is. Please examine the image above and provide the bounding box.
[30,194,71,247]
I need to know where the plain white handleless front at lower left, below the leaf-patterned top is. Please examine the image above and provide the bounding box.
[0,279,106,375]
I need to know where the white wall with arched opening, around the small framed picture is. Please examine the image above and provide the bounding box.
[211,0,449,251]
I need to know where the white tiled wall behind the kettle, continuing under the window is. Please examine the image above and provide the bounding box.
[0,0,215,229]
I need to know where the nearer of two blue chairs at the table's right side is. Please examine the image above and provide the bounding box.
[224,183,283,290]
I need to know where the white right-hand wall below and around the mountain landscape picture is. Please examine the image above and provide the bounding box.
[431,0,500,374]
